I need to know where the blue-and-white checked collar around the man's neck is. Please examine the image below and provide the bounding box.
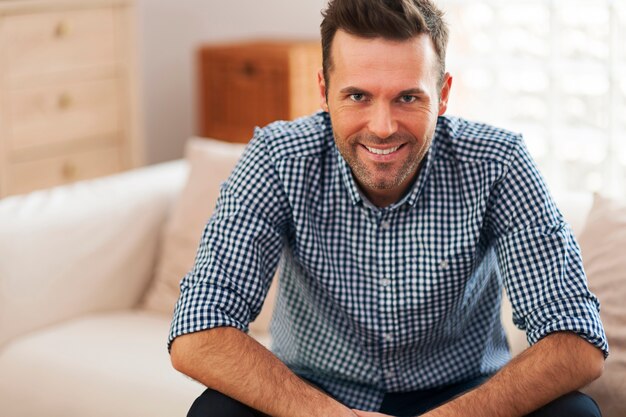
[333,118,440,210]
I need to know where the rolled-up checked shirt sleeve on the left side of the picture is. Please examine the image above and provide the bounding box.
[168,131,289,349]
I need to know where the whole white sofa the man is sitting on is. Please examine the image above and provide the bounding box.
[0,141,612,417]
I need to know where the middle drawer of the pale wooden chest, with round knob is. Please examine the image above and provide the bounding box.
[6,79,122,152]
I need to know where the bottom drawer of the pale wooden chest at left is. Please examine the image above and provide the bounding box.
[6,147,124,194]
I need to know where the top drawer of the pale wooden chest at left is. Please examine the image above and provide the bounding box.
[2,8,117,77]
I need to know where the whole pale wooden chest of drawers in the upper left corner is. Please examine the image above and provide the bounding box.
[0,0,143,197]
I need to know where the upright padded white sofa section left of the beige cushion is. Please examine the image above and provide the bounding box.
[0,161,188,346]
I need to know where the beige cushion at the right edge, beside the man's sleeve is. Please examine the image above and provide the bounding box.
[580,195,626,417]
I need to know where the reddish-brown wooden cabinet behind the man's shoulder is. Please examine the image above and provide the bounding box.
[198,41,322,142]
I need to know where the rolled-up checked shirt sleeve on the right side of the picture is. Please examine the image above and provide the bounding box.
[490,138,609,356]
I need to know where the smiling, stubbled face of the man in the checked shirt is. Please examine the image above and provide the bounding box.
[318,30,452,207]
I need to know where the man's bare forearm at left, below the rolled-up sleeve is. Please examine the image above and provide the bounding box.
[171,327,355,417]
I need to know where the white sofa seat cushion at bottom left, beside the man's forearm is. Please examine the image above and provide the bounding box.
[0,310,205,417]
